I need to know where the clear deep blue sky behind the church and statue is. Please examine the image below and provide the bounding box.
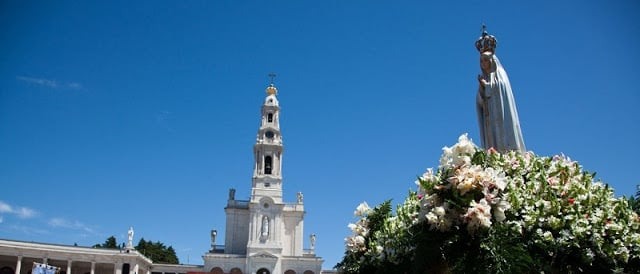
[0,0,640,268]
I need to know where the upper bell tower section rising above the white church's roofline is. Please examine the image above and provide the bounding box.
[251,79,283,203]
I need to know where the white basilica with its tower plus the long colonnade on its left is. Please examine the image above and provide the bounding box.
[0,83,328,274]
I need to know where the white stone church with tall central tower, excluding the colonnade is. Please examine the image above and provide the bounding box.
[203,78,323,274]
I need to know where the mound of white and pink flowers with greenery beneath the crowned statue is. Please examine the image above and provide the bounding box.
[337,134,640,273]
